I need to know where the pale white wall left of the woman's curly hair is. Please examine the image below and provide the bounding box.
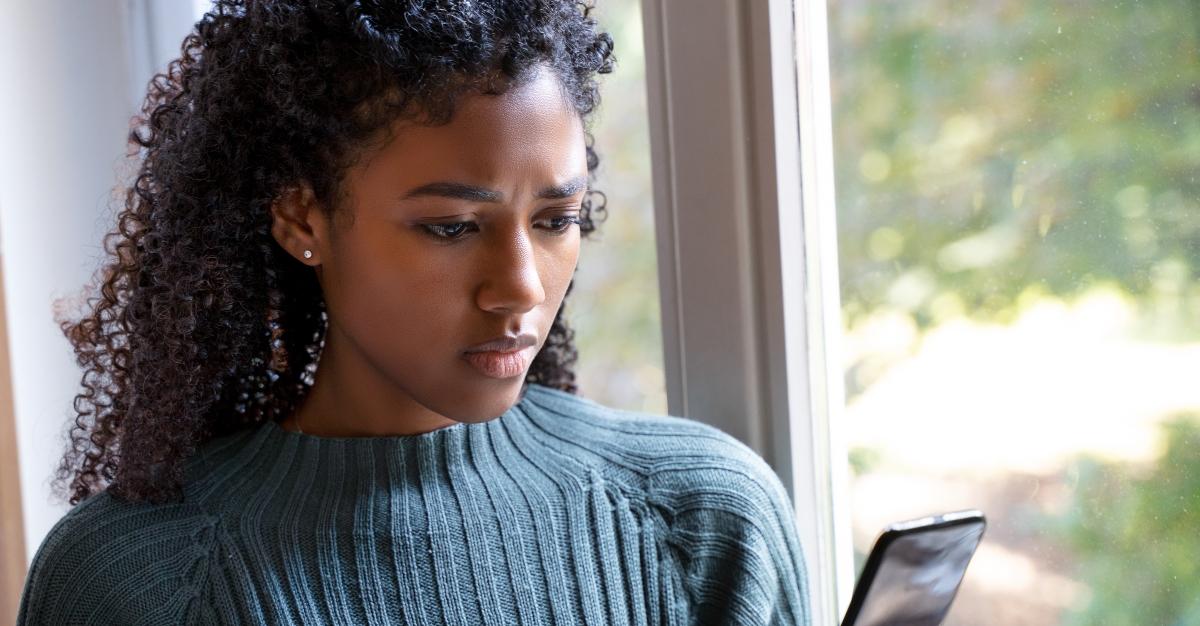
[0,0,193,559]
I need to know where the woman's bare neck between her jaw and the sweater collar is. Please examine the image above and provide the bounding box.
[284,325,458,437]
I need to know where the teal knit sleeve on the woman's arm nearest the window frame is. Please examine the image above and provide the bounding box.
[655,429,811,626]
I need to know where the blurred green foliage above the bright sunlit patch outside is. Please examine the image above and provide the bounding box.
[829,0,1200,327]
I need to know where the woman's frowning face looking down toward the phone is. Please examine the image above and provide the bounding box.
[295,72,588,421]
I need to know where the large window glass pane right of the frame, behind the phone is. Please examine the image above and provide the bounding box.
[829,0,1200,626]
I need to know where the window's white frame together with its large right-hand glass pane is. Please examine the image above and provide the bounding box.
[644,0,1200,624]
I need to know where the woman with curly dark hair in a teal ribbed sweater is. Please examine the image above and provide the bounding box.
[18,0,809,626]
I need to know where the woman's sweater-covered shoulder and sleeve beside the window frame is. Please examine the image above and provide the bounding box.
[520,387,811,626]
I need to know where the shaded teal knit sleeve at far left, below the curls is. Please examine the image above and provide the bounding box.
[17,493,215,626]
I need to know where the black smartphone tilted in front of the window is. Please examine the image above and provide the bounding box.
[841,511,988,626]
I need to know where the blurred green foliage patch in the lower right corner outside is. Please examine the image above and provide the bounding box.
[1055,415,1200,626]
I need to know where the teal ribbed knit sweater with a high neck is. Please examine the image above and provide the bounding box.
[17,385,810,626]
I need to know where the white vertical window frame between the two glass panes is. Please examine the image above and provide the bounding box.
[638,0,854,624]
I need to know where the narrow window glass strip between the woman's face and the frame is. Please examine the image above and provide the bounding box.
[566,0,667,413]
